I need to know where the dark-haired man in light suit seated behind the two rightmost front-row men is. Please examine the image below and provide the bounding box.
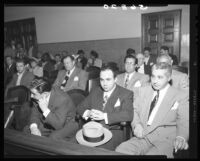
[117,55,149,97]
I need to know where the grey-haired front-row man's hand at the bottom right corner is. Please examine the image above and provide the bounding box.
[174,136,189,153]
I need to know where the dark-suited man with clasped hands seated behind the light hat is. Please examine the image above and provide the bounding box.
[77,66,133,150]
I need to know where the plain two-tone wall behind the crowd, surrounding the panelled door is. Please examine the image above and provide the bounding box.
[4,5,190,61]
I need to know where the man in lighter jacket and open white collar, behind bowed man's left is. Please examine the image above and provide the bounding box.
[5,59,34,96]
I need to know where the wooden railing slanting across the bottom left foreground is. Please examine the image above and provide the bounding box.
[4,129,123,157]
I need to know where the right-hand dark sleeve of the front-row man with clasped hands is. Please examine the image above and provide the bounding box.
[107,92,133,124]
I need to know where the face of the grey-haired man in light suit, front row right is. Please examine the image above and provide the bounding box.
[151,69,171,90]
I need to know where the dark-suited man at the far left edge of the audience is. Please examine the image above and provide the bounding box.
[4,56,17,87]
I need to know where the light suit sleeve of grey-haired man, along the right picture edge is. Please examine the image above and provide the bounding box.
[176,92,189,140]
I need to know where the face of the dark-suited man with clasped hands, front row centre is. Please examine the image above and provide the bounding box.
[100,69,116,92]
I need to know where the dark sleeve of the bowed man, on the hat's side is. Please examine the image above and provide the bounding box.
[45,96,75,130]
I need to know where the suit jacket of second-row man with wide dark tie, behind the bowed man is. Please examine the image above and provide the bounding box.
[53,67,88,91]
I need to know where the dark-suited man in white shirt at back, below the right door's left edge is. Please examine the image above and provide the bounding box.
[143,47,156,76]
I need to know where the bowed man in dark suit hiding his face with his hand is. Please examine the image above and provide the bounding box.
[24,79,78,139]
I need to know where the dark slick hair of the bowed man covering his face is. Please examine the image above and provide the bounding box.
[30,78,51,94]
